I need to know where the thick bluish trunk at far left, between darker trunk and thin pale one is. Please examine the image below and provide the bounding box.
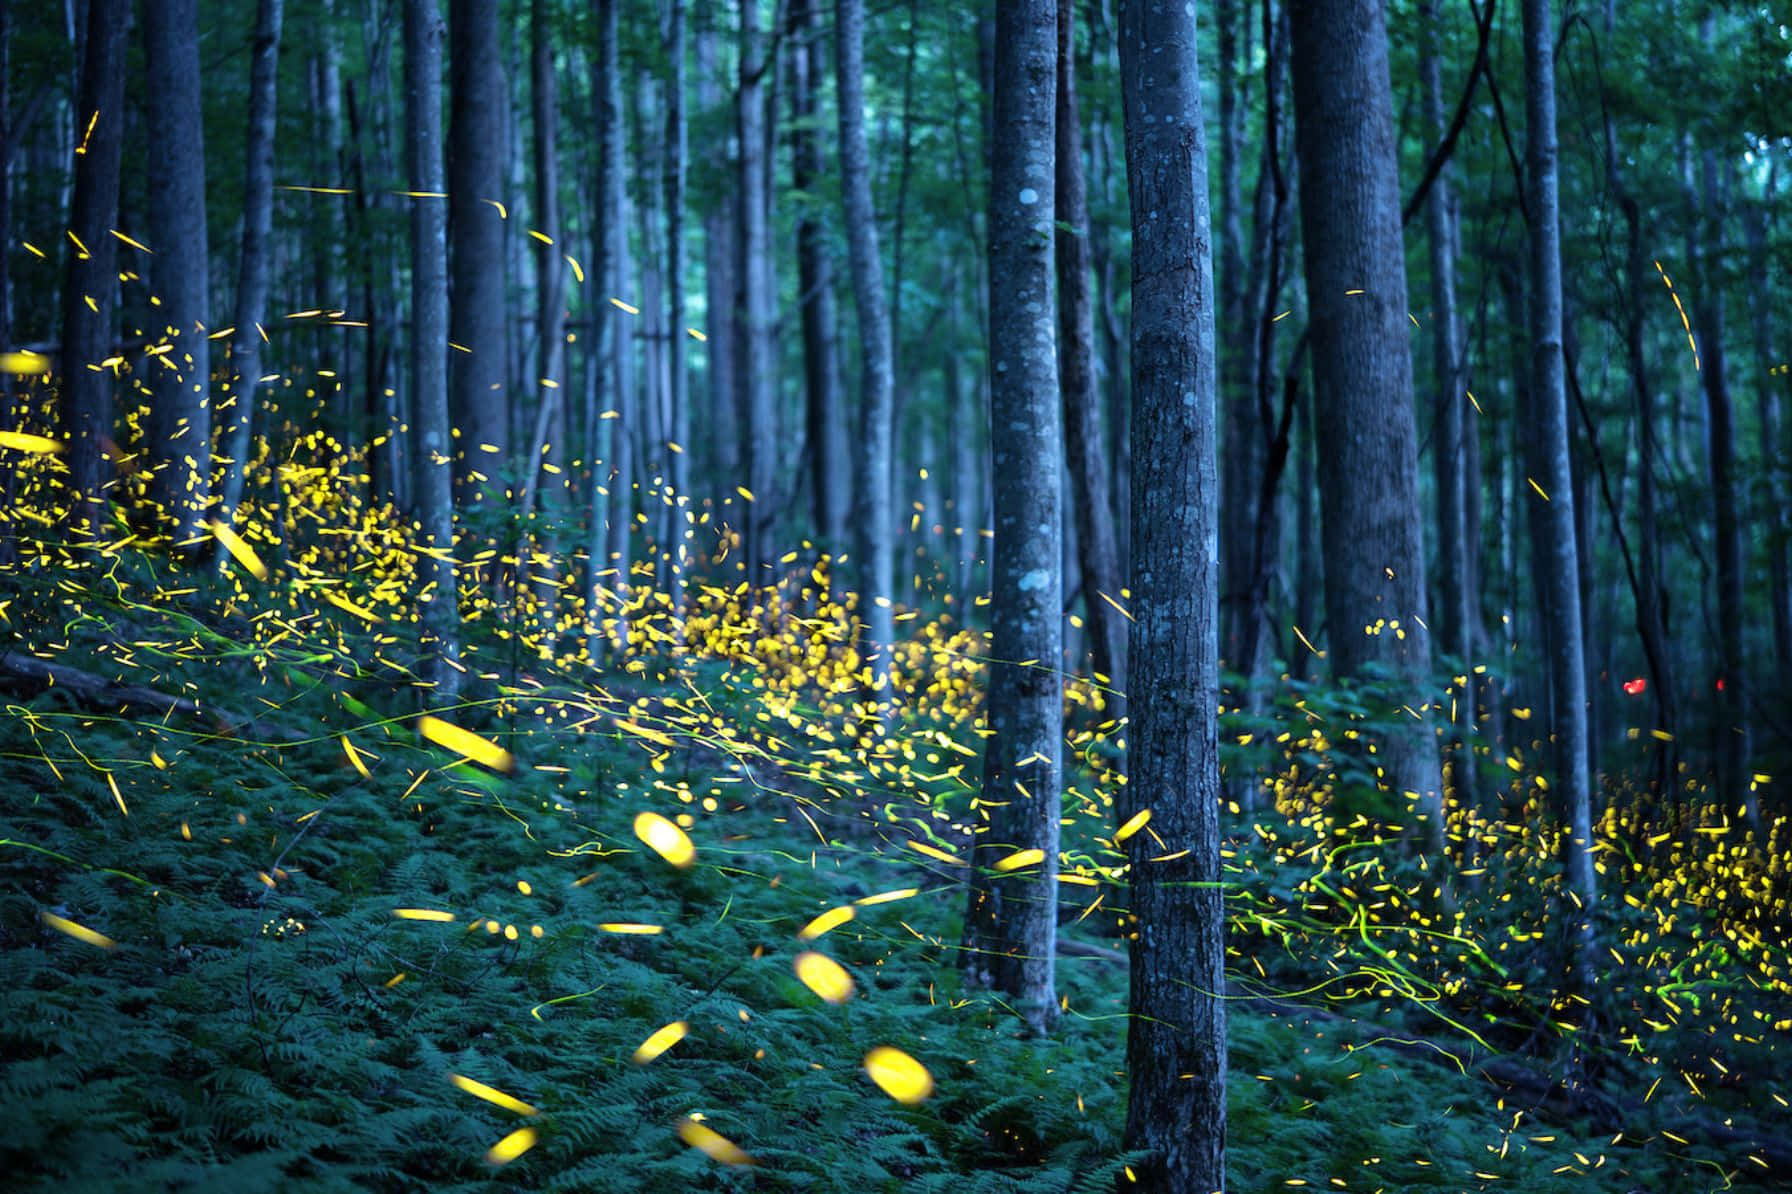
[143,0,211,547]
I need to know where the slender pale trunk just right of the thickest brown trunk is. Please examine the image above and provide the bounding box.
[1523,0,1598,990]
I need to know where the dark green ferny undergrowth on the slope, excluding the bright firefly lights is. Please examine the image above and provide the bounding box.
[0,559,1765,1194]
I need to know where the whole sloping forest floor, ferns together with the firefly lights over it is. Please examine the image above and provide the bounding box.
[0,505,1792,1194]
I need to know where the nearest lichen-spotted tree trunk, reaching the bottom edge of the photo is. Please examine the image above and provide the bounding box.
[1116,0,1226,1194]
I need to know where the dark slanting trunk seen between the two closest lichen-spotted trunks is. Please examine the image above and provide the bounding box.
[1055,0,1125,699]
